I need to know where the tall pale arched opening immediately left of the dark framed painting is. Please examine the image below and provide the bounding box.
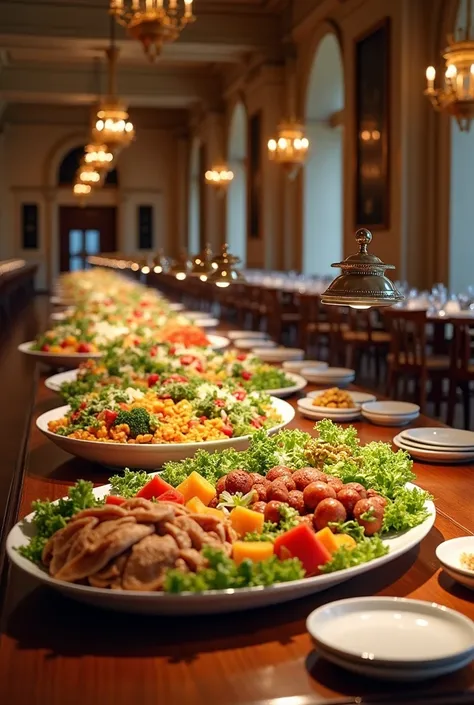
[302,33,344,274]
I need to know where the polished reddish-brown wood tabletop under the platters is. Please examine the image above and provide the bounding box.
[0,296,474,705]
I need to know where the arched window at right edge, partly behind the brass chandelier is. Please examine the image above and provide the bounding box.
[449,0,474,293]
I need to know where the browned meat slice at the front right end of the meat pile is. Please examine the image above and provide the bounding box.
[122,534,179,591]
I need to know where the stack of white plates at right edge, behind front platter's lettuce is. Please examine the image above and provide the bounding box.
[393,426,474,463]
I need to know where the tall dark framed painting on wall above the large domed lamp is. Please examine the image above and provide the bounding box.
[355,17,390,230]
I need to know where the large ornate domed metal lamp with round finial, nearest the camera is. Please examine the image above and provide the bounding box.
[321,228,405,309]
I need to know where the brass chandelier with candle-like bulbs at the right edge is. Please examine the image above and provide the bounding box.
[425,0,474,132]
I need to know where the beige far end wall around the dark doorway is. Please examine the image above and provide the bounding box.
[0,106,182,288]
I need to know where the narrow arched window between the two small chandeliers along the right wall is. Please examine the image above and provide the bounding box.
[226,103,247,266]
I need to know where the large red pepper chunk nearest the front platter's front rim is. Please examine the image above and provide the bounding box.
[273,524,331,575]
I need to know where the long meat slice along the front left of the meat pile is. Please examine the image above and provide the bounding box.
[54,522,154,583]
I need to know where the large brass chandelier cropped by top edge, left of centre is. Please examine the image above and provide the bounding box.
[110,0,196,61]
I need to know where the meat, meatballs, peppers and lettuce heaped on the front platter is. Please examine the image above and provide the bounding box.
[19,420,431,593]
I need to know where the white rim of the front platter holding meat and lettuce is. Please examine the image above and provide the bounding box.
[6,482,436,615]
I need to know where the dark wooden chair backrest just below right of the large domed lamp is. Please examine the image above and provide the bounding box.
[385,309,427,370]
